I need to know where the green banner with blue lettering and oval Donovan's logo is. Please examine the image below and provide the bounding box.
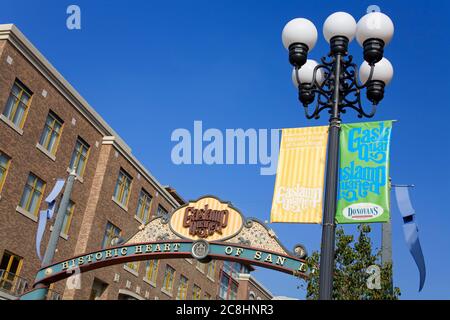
[336,121,392,223]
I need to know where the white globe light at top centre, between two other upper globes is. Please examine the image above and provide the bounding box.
[323,12,356,43]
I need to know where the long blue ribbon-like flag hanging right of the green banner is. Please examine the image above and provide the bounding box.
[392,185,426,291]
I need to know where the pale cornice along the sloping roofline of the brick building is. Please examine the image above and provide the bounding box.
[0,24,178,208]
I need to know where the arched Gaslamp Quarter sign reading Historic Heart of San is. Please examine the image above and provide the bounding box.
[29,196,307,296]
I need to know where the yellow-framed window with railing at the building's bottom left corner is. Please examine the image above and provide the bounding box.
[0,251,23,293]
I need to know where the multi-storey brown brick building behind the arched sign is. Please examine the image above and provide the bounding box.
[0,25,271,299]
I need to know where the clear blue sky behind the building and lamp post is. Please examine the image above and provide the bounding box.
[0,0,450,299]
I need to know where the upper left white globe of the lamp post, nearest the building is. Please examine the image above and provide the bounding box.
[281,18,317,51]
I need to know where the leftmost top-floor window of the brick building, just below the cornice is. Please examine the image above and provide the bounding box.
[3,80,32,129]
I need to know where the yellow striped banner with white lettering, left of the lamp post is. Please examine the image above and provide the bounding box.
[270,126,328,223]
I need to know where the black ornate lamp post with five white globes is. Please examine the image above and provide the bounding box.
[282,12,394,300]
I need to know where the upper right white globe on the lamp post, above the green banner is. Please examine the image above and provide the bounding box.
[356,12,394,45]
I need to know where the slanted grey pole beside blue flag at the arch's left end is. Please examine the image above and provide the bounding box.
[20,170,77,300]
